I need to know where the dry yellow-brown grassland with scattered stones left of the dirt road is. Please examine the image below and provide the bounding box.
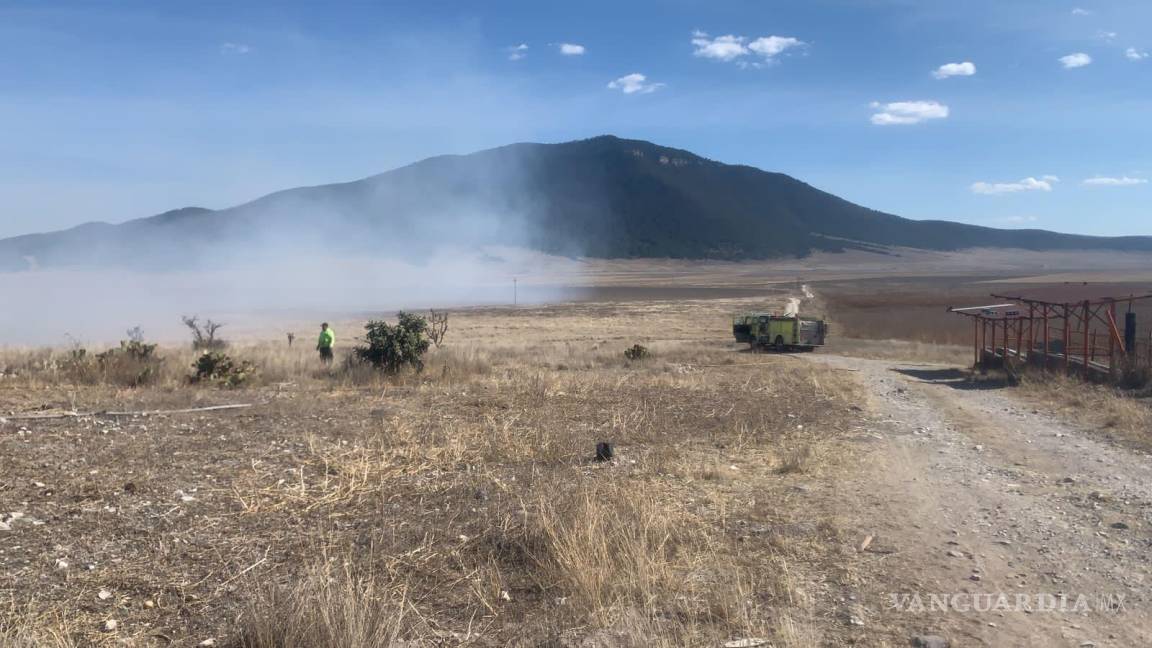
[0,300,859,648]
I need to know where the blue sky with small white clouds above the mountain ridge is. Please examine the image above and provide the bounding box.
[0,0,1152,236]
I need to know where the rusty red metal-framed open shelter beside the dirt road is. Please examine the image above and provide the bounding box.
[948,284,1152,382]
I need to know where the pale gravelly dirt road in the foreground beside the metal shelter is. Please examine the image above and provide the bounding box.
[802,354,1152,648]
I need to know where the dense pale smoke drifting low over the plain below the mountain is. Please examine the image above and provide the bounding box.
[0,248,563,347]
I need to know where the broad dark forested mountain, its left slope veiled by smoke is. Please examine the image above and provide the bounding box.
[0,136,1152,271]
